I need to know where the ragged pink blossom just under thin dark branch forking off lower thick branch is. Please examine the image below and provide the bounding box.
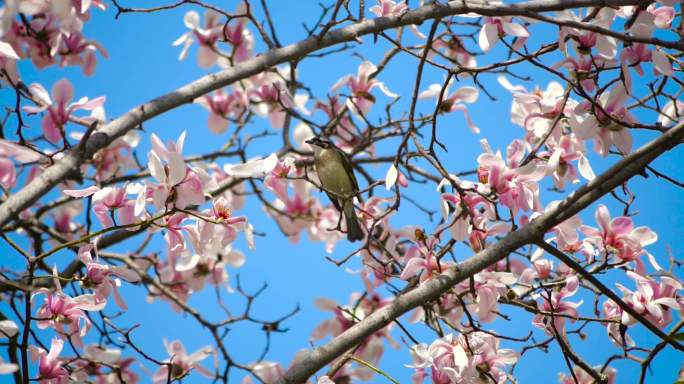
[532,275,583,337]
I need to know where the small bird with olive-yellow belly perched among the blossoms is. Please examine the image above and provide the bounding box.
[306,137,364,242]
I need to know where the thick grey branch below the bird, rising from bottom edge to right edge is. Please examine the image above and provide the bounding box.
[280,121,684,384]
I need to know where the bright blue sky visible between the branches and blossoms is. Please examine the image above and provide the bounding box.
[0,0,684,383]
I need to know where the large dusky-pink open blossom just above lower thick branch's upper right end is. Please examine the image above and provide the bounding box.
[570,83,637,157]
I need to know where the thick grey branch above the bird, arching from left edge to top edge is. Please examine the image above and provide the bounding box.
[0,0,640,227]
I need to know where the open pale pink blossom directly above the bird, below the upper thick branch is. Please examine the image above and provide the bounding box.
[331,61,399,115]
